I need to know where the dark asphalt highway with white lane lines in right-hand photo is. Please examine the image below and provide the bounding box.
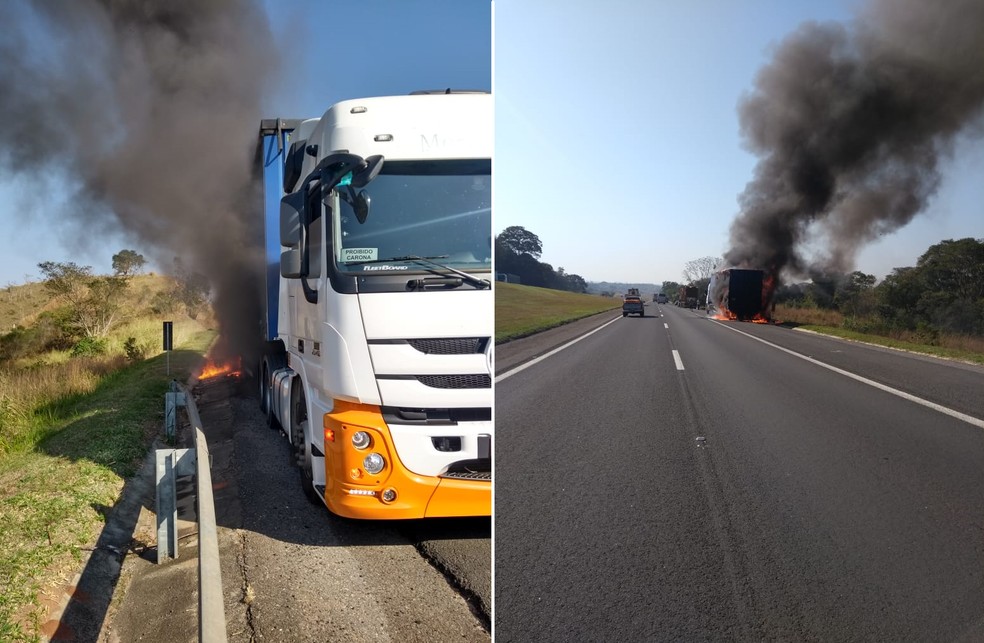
[494,303,984,642]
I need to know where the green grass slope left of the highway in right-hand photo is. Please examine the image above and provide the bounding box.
[495,282,622,344]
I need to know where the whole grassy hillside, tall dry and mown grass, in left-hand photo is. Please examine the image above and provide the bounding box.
[0,275,215,641]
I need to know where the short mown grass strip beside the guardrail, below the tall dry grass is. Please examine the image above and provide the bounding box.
[0,330,215,641]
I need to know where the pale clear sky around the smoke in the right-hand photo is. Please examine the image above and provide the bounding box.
[494,0,984,283]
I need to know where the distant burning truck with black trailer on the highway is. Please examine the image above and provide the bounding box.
[707,268,775,324]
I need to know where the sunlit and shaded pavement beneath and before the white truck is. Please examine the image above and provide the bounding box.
[106,382,491,643]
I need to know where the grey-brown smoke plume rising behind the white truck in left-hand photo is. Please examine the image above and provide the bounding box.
[0,0,276,357]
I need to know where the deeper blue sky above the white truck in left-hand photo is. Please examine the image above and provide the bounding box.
[0,0,492,287]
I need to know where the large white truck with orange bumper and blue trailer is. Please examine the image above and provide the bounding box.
[257,91,494,519]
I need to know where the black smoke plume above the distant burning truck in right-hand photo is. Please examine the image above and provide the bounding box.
[725,0,984,276]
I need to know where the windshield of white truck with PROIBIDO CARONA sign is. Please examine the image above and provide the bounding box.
[332,159,492,274]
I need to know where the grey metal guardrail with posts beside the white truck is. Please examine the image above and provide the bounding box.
[156,382,227,643]
